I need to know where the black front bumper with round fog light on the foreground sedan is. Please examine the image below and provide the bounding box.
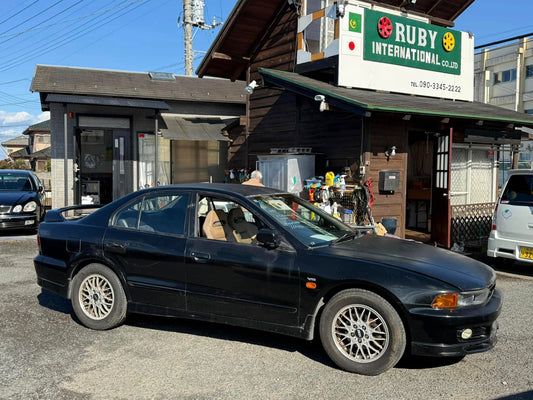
[410,289,503,357]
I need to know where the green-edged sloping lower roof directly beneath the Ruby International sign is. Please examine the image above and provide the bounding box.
[259,68,533,128]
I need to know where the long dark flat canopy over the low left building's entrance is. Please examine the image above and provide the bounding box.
[45,93,170,110]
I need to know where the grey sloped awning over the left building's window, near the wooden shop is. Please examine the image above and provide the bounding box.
[159,113,235,141]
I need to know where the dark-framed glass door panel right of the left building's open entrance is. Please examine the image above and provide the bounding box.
[113,129,133,200]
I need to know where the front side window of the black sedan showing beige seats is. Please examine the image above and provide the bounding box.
[197,197,264,244]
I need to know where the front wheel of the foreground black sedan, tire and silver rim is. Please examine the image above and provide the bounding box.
[319,289,406,375]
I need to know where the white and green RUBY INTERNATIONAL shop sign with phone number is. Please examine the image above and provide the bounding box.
[337,2,474,101]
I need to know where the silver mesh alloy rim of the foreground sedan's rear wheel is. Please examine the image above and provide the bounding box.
[79,274,115,320]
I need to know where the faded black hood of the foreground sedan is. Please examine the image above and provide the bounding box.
[316,235,496,291]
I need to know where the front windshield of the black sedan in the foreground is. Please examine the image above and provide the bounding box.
[253,194,355,247]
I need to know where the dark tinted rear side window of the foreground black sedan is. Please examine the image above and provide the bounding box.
[112,193,189,235]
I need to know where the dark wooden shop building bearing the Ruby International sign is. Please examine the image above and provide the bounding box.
[197,0,533,247]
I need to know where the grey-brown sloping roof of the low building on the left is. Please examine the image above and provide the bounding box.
[30,65,246,104]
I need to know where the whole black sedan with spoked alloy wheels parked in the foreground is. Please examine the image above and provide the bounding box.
[35,184,502,375]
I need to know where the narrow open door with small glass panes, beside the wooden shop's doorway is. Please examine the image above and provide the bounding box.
[431,129,452,248]
